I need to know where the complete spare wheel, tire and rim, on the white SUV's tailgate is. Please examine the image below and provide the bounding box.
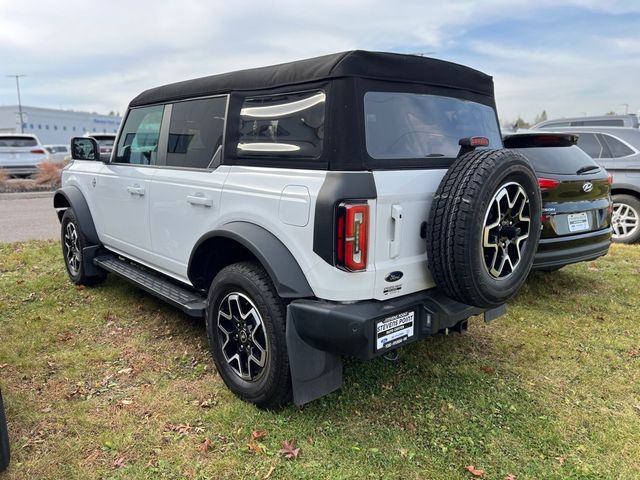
[427,150,542,308]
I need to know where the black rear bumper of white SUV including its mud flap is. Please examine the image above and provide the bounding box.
[286,288,506,405]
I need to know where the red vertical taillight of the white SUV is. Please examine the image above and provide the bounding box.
[336,202,369,272]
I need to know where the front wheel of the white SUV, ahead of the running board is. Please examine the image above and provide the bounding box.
[60,208,107,286]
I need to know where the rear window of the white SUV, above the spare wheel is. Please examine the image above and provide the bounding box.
[364,92,502,159]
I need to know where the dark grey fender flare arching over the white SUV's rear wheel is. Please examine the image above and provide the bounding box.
[187,221,314,298]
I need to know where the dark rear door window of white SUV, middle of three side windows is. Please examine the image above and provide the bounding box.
[166,96,227,168]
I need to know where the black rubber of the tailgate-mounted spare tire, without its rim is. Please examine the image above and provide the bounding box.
[427,150,542,308]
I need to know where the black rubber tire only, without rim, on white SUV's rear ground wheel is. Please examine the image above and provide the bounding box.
[206,262,292,409]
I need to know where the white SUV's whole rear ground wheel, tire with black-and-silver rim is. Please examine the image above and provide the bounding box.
[206,262,291,409]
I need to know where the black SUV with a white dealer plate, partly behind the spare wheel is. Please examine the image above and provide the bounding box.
[504,132,612,270]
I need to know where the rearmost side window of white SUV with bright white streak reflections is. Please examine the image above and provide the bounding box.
[237,91,326,158]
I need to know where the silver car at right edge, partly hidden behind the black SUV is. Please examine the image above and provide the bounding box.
[536,127,640,243]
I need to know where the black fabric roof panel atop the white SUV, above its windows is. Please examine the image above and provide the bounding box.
[130,50,493,107]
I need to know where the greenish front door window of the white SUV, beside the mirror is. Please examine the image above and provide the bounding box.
[113,105,164,165]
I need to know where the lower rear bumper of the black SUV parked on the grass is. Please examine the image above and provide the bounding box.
[533,228,612,270]
